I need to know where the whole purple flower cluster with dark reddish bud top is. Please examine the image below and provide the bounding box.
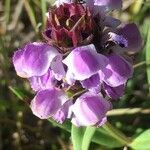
[13,0,142,126]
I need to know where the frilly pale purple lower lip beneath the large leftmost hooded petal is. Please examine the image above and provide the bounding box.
[29,69,57,91]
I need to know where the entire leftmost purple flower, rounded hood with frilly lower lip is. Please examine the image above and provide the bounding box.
[13,42,65,91]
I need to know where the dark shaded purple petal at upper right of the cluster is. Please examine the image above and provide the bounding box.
[117,23,142,52]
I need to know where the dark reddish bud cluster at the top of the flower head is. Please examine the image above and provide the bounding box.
[43,3,101,53]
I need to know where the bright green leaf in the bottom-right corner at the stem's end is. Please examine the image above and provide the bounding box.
[130,129,150,150]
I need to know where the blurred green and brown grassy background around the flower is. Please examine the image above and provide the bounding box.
[0,0,150,150]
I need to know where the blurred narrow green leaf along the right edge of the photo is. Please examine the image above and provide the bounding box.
[146,26,150,92]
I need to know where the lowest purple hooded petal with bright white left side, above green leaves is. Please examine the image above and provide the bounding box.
[72,93,111,126]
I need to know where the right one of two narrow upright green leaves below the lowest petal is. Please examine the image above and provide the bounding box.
[81,127,96,150]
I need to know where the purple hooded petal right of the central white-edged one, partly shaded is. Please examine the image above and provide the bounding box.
[99,54,133,87]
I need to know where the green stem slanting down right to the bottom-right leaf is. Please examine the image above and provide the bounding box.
[102,122,131,145]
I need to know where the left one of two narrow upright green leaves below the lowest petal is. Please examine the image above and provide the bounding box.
[71,124,85,150]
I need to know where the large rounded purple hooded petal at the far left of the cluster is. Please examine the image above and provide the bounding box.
[13,42,59,78]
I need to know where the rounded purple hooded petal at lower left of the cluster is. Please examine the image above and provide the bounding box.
[30,88,67,119]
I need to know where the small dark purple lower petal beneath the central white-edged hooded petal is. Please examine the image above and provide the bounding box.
[81,74,101,93]
